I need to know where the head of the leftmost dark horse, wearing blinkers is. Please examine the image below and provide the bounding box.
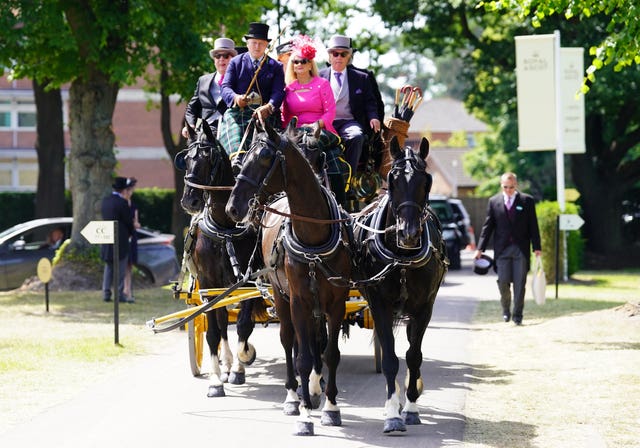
[174,120,233,215]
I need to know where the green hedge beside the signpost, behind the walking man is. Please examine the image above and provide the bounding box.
[536,201,584,283]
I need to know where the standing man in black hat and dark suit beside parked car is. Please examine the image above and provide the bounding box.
[100,177,135,303]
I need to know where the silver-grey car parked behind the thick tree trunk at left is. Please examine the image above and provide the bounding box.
[0,217,179,290]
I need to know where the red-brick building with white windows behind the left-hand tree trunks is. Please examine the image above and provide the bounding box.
[0,76,184,191]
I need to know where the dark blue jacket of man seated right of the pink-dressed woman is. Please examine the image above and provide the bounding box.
[320,66,382,132]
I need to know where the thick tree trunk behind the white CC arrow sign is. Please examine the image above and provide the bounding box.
[69,75,119,252]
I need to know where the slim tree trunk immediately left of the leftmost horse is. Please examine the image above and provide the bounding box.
[160,70,190,260]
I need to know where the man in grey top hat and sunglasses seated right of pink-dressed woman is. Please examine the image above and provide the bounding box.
[320,35,381,182]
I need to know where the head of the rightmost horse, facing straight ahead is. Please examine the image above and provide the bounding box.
[387,137,433,249]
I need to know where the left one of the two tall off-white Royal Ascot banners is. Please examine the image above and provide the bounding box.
[515,34,556,151]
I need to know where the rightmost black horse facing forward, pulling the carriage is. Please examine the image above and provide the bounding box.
[355,137,448,433]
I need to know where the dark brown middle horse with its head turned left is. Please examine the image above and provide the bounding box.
[226,120,352,435]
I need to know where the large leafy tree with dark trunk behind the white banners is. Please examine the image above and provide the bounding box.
[374,0,640,260]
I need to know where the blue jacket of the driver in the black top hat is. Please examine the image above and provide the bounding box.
[222,53,284,110]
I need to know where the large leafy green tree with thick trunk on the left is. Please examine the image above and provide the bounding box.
[0,0,269,270]
